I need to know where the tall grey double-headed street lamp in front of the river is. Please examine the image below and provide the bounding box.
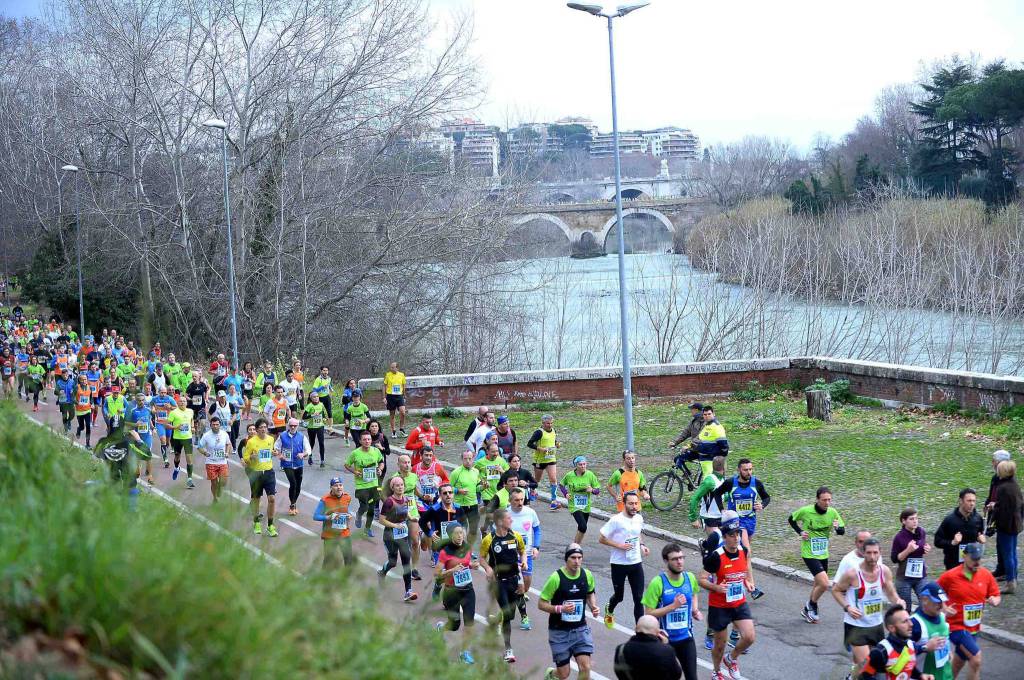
[567,2,650,451]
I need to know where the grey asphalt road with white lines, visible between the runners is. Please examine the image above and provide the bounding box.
[19,399,1024,680]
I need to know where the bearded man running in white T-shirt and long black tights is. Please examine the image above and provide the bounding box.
[598,491,650,628]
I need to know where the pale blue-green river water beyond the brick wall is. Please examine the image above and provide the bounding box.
[503,250,1024,375]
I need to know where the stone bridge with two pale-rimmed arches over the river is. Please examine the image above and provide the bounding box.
[511,200,713,255]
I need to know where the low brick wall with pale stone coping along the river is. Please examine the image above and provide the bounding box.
[359,356,1024,412]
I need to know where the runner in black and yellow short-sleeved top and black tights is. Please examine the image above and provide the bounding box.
[480,508,526,664]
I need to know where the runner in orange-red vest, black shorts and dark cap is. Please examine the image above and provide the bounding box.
[698,518,756,680]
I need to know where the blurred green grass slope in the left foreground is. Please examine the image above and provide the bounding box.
[0,402,499,679]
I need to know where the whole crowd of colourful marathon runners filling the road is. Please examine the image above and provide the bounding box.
[0,307,1022,680]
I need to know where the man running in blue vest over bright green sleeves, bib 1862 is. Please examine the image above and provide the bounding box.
[641,543,703,680]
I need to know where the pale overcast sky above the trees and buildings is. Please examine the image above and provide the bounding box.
[9,0,1024,148]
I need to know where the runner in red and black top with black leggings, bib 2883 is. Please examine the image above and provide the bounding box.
[434,525,480,664]
